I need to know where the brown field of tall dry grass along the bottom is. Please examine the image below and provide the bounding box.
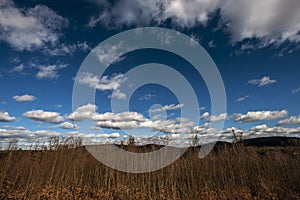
[0,138,300,199]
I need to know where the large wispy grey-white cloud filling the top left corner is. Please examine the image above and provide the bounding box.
[0,1,67,51]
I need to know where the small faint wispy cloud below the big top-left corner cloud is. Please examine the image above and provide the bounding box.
[36,64,67,79]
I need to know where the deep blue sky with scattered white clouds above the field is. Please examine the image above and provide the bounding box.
[0,0,300,148]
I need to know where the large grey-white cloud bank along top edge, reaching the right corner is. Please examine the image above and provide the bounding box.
[89,0,300,48]
